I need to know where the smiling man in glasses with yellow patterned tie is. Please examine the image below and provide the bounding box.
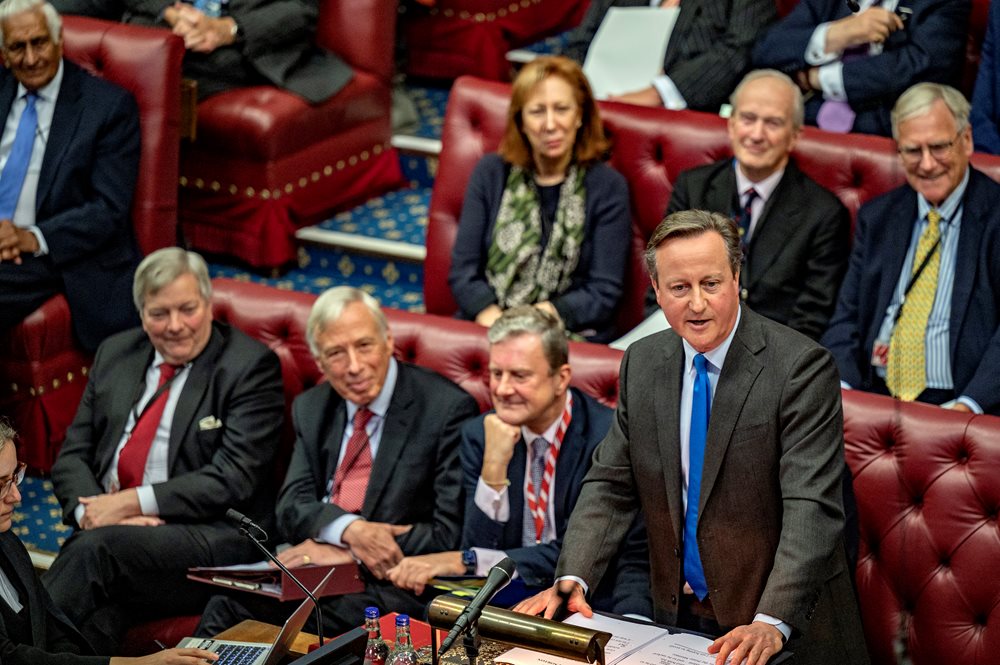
[822,83,1000,414]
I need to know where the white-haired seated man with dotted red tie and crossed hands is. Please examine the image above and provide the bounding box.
[198,286,479,636]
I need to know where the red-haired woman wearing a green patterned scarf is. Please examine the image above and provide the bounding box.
[448,57,631,341]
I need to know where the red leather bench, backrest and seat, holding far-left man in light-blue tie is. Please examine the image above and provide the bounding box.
[0,16,184,471]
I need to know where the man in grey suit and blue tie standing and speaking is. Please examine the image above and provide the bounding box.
[519,211,868,665]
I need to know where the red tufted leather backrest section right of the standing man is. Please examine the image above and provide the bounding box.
[844,391,1000,665]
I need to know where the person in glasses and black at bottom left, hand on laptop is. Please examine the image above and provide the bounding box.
[0,419,218,665]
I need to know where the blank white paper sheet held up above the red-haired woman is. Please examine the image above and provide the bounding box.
[583,7,681,99]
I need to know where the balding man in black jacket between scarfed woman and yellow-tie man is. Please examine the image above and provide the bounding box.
[653,69,851,339]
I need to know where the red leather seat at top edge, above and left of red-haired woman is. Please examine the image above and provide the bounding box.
[400,0,589,81]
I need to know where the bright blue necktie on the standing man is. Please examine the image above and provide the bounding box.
[684,353,712,600]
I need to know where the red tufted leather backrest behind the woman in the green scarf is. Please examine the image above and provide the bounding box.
[424,77,1000,332]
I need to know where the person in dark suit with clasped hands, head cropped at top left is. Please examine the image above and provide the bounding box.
[53,0,354,104]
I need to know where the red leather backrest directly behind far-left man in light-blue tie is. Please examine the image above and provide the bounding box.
[63,16,184,254]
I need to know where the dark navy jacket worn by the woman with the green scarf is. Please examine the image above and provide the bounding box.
[448,154,632,342]
